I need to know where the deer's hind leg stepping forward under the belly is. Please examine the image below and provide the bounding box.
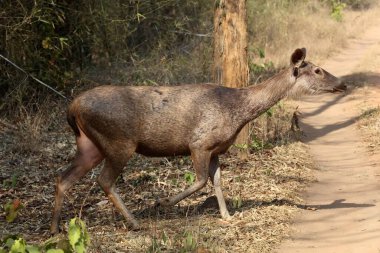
[98,154,139,229]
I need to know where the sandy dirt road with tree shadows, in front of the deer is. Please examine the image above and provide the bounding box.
[277,23,380,253]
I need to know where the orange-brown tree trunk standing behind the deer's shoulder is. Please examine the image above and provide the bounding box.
[213,0,249,158]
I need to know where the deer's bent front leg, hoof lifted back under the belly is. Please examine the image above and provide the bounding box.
[157,150,211,206]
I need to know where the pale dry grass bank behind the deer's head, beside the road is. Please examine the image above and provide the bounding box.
[251,1,380,66]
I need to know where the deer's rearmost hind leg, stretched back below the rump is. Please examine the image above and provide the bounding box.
[50,132,104,234]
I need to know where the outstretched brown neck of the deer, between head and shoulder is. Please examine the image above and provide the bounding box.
[242,68,295,124]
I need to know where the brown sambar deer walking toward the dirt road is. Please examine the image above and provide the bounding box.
[51,48,345,233]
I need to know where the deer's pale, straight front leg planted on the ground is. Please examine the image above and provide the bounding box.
[209,156,231,220]
